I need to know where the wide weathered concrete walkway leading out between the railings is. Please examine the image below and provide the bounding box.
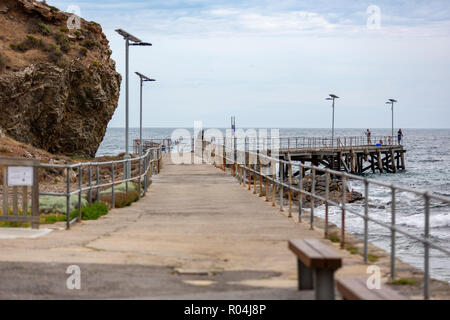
[0,159,414,299]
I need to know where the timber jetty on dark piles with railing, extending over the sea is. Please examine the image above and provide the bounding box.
[236,136,406,174]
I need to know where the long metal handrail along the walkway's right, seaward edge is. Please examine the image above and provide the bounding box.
[202,140,450,299]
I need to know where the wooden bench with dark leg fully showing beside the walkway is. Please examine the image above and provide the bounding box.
[289,239,342,300]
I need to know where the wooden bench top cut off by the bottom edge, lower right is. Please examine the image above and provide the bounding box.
[336,278,407,300]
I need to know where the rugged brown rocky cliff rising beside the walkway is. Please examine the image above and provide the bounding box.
[0,0,121,157]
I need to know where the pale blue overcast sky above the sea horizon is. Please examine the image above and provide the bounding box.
[47,0,450,128]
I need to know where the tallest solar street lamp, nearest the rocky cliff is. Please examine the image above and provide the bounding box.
[116,29,152,179]
